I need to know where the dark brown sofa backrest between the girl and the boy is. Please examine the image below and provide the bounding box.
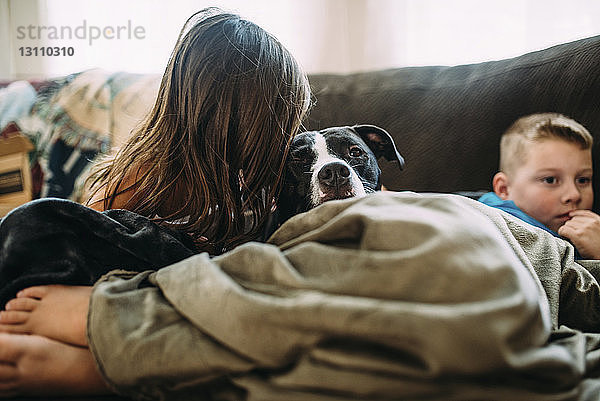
[305,36,600,212]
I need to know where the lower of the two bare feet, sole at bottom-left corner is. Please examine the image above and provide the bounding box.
[0,333,110,398]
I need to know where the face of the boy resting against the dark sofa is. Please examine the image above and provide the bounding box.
[499,139,594,232]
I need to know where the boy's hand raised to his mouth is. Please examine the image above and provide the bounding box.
[558,209,600,259]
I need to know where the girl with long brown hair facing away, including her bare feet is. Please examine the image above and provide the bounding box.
[0,8,310,397]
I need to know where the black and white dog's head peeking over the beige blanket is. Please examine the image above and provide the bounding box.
[277,125,404,222]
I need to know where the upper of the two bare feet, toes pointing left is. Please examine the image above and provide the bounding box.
[0,285,92,347]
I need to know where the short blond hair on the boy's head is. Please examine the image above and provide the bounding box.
[500,113,594,174]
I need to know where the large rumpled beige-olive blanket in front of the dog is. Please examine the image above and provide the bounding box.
[88,193,600,401]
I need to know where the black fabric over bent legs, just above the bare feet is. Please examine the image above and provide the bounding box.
[0,198,195,308]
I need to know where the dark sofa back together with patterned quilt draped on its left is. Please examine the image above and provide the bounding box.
[3,36,600,400]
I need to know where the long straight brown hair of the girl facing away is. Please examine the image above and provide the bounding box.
[89,8,310,253]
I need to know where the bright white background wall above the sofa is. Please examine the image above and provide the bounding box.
[0,0,600,79]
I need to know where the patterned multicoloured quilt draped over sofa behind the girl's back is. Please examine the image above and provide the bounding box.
[0,69,160,201]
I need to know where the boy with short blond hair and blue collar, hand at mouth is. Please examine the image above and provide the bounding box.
[479,113,600,259]
